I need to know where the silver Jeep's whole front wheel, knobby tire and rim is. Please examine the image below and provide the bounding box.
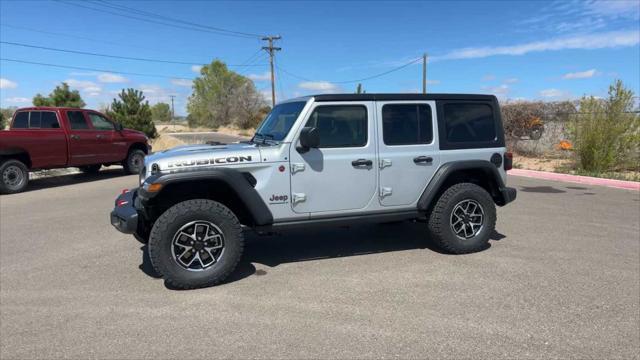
[148,199,244,289]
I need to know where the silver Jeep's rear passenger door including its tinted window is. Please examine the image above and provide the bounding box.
[376,101,440,206]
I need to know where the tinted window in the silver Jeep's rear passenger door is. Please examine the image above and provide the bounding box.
[382,104,433,145]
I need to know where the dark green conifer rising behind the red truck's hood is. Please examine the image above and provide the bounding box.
[106,88,158,138]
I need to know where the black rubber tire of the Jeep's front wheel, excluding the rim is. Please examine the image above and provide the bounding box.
[148,199,244,289]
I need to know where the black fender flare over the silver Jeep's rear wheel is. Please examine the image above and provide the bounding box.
[418,160,510,211]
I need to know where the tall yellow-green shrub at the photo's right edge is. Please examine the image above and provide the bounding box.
[571,80,640,172]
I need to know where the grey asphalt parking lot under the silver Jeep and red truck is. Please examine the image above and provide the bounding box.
[0,170,640,359]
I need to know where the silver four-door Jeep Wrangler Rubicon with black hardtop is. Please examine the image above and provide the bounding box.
[111,94,516,289]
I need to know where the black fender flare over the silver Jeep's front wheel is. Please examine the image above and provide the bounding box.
[138,168,273,226]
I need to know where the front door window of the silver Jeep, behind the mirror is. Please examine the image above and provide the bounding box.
[305,105,367,148]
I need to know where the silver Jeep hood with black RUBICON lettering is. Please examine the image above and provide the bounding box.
[145,143,261,171]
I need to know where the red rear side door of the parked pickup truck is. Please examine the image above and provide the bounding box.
[65,110,102,166]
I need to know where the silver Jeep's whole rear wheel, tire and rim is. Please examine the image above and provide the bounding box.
[428,183,496,254]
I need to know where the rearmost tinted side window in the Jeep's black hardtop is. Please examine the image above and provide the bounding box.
[444,103,497,143]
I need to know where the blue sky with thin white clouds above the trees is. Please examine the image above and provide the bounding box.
[0,0,640,114]
